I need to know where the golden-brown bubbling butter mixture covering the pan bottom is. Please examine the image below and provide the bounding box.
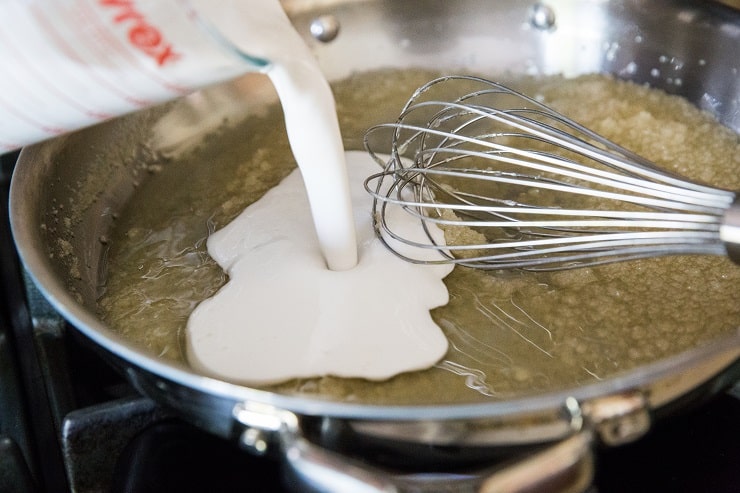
[99,71,740,404]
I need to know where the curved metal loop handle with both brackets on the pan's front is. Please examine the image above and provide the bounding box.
[234,390,651,493]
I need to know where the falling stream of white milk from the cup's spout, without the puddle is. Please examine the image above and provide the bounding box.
[190,0,357,270]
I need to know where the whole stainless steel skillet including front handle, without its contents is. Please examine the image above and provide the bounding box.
[11,0,740,491]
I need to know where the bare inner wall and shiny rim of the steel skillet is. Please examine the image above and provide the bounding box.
[7,1,740,430]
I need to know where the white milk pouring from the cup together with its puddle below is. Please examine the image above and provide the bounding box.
[187,0,452,384]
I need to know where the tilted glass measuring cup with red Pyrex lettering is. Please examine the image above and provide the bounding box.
[0,0,269,154]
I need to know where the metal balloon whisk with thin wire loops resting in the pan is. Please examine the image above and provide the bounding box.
[365,76,740,270]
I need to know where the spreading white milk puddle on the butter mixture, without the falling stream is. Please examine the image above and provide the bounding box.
[187,152,452,384]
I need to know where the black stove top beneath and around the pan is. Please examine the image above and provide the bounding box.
[0,151,740,493]
